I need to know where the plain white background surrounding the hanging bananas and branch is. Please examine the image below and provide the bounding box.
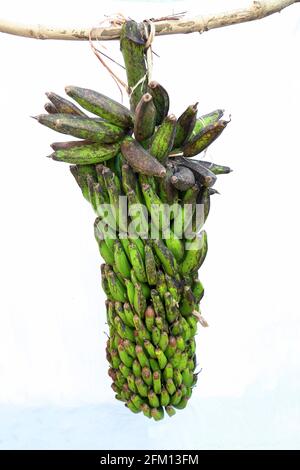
[0,0,300,449]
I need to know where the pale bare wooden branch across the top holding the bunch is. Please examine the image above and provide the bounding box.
[0,0,300,41]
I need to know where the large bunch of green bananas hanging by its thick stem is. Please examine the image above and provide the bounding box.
[36,21,231,420]
